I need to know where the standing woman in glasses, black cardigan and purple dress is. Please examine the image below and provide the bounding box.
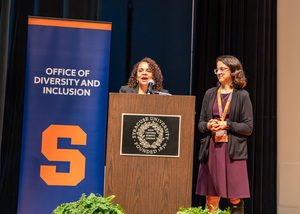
[196,55,253,214]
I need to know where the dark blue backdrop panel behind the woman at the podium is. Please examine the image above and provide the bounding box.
[101,0,192,95]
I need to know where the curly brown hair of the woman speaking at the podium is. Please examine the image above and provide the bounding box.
[127,57,163,91]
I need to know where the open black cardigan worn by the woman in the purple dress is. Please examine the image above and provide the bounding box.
[198,87,253,161]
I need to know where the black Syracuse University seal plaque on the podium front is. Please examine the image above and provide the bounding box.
[121,114,180,157]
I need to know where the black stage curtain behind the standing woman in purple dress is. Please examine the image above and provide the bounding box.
[193,0,277,214]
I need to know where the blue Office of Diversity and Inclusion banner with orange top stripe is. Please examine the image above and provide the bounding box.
[18,18,111,214]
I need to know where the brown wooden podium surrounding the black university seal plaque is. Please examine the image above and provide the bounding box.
[104,93,195,214]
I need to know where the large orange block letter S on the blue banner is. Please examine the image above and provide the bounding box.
[40,125,87,186]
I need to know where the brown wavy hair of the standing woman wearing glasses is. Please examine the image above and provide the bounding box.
[216,55,247,88]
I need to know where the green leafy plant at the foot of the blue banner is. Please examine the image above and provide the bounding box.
[52,193,125,214]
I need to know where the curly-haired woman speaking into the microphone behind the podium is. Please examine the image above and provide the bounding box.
[119,57,168,94]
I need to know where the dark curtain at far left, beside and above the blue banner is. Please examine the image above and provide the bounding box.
[0,0,101,214]
